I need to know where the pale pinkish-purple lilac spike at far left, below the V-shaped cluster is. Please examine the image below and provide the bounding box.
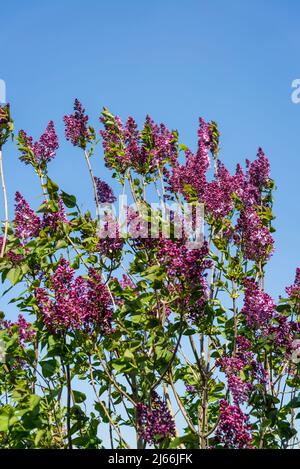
[15,192,41,241]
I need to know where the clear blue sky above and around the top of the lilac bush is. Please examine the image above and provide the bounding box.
[0,0,300,304]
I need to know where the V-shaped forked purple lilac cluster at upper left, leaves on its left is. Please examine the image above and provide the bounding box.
[18,121,59,169]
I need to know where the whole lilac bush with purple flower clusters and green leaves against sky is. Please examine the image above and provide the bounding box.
[0,99,300,450]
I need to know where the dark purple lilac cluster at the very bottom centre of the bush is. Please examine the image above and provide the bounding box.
[137,392,175,443]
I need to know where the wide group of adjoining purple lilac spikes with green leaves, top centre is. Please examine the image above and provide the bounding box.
[100,109,177,174]
